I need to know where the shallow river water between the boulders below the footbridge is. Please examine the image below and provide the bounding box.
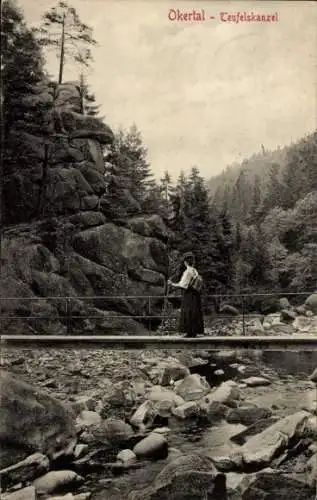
[87,351,317,500]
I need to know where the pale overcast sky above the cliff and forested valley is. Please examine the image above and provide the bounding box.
[19,0,317,179]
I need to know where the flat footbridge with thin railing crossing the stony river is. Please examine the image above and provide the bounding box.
[0,292,317,351]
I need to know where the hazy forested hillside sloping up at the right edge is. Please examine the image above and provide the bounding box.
[205,135,317,291]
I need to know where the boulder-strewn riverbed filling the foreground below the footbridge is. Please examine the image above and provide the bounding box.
[0,349,317,500]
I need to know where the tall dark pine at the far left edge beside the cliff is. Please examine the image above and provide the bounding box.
[1,0,51,222]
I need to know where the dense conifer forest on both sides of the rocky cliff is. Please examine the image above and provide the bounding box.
[1,0,317,304]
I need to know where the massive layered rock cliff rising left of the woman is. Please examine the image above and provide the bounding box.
[0,84,167,334]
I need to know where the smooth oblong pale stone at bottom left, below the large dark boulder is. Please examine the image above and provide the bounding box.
[33,470,84,495]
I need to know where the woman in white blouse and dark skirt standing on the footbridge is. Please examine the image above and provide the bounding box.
[168,252,204,337]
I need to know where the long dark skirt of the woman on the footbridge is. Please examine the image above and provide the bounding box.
[179,287,204,337]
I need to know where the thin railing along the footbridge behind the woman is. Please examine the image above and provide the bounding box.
[0,292,317,336]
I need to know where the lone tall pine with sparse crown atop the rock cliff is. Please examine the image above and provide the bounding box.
[33,1,97,83]
